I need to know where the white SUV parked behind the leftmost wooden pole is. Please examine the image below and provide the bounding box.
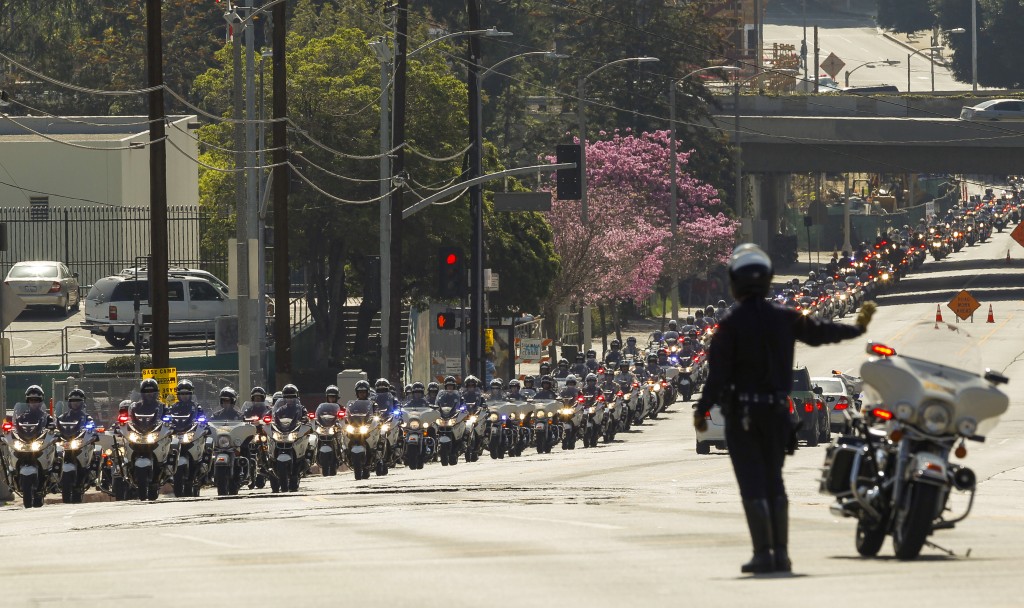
[83,272,233,348]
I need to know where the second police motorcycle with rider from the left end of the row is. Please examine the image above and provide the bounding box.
[55,389,100,504]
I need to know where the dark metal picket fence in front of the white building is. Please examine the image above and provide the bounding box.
[0,206,227,286]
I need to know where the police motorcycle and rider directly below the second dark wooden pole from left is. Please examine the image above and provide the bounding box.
[266,384,316,493]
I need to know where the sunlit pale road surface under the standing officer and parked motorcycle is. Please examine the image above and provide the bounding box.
[0,229,1024,607]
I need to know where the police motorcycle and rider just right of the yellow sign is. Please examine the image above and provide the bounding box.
[165,380,213,498]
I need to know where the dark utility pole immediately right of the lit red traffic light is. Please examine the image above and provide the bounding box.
[466,0,486,382]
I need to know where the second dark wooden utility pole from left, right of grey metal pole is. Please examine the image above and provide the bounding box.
[271,2,292,387]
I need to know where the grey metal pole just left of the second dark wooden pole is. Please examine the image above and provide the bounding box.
[230,3,255,394]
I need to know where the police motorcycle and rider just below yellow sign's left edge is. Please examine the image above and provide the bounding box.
[112,379,175,501]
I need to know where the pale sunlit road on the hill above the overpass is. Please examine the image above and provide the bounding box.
[764,0,971,92]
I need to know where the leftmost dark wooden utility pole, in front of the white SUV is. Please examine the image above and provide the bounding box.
[145,0,171,367]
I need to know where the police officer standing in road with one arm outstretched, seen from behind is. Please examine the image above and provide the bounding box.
[693,244,874,573]
